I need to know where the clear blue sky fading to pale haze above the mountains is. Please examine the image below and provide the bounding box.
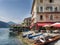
[0,0,33,23]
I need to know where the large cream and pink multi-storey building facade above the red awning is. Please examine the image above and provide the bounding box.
[31,0,60,28]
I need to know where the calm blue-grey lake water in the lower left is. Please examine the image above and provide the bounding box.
[0,28,22,45]
